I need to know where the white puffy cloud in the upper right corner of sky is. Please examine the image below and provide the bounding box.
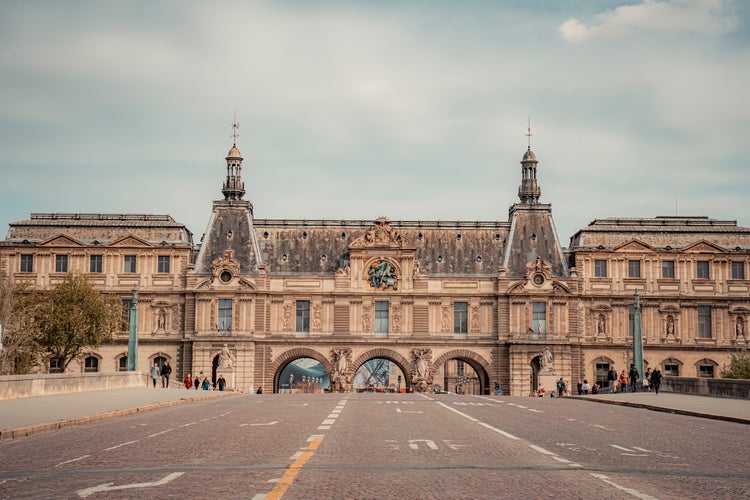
[558,0,738,43]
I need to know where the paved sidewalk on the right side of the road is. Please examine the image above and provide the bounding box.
[573,392,750,424]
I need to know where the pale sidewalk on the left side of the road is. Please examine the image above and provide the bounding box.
[0,387,238,439]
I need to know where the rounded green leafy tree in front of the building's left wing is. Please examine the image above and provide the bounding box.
[34,273,123,371]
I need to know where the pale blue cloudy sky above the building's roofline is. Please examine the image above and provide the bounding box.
[0,0,750,246]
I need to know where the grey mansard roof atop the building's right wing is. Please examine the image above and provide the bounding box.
[570,216,750,250]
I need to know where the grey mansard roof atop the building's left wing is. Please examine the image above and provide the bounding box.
[3,213,193,247]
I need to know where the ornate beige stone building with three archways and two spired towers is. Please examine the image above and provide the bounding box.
[0,137,750,395]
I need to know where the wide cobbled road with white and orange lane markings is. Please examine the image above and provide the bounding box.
[0,394,750,499]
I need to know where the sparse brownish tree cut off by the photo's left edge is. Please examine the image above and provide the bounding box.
[0,273,41,375]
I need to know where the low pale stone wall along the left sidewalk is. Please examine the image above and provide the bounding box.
[0,372,148,399]
